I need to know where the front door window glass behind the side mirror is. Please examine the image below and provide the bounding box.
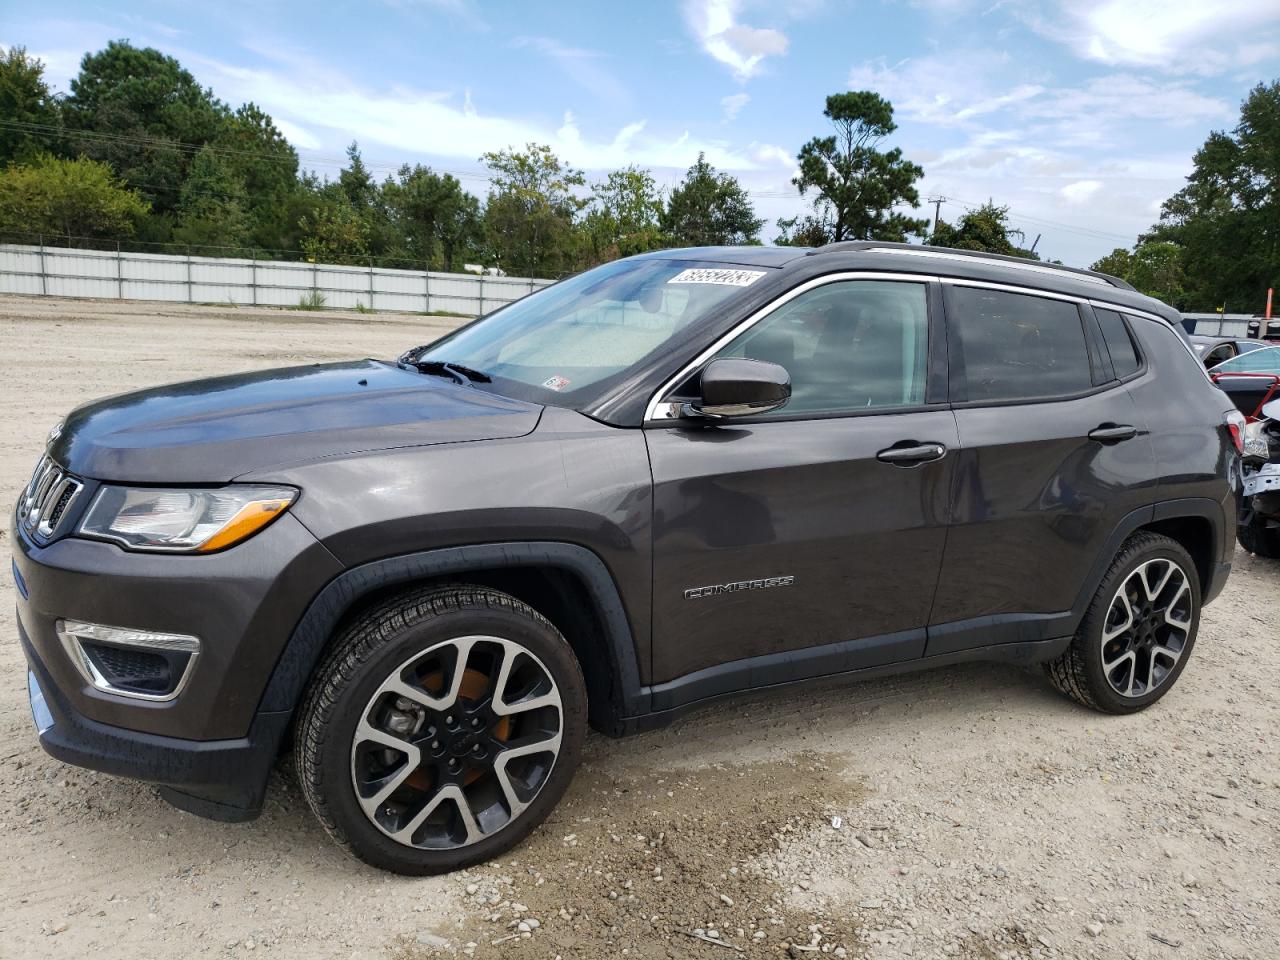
[717,280,929,419]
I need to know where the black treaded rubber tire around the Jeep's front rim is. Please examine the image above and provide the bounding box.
[294,585,586,876]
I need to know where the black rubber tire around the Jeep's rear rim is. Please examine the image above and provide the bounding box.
[1044,532,1201,714]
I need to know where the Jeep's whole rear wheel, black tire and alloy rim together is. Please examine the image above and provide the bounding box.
[1046,534,1201,713]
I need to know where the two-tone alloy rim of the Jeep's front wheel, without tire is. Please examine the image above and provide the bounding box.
[351,636,563,850]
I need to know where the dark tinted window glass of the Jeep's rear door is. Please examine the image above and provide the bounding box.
[947,287,1093,401]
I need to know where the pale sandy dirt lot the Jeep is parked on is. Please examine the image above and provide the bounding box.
[0,298,1280,960]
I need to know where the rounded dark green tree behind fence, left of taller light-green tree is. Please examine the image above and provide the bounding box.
[381,164,481,270]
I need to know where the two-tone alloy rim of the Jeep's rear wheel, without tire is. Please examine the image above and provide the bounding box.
[1102,559,1194,698]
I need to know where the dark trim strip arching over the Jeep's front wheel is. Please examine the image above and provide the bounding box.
[257,541,649,717]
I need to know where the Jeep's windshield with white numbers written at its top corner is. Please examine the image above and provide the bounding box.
[408,260,765,406]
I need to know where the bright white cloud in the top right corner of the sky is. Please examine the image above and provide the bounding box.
[1011,0,1280,74]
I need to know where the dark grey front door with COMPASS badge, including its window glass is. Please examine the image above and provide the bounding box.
[645,279,957,709]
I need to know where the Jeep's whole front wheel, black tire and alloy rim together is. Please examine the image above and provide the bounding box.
[297,586,586,874]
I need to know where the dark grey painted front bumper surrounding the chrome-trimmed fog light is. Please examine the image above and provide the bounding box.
[10,515,340,740]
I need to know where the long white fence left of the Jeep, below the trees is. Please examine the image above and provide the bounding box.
[0,243,550,316]
